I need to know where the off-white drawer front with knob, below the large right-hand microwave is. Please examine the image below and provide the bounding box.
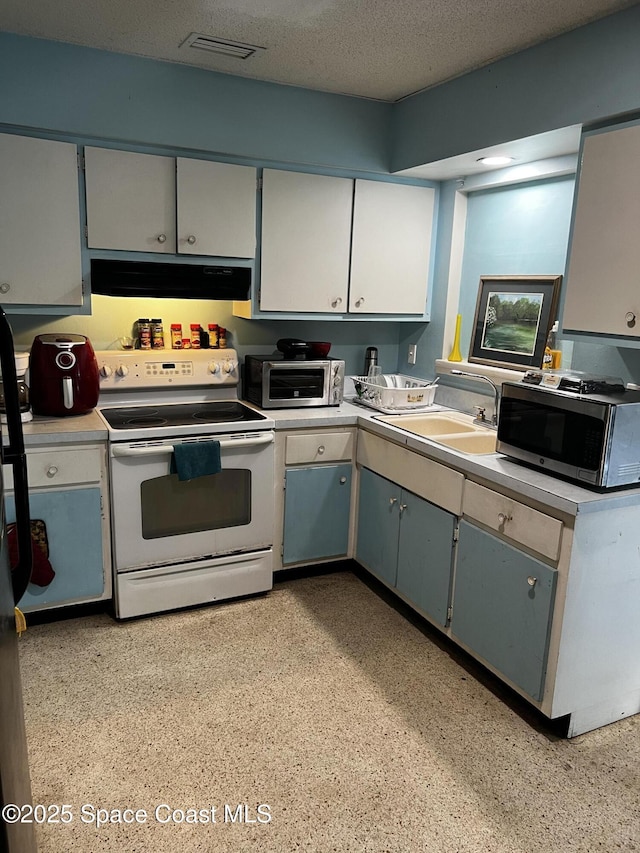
[462,481,563,561]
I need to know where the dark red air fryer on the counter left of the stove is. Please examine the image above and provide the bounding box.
[29,335,100,417]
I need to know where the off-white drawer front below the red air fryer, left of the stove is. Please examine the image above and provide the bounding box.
[2,447,101,491]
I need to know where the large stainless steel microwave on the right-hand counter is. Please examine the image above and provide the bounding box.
[497,382,640,489]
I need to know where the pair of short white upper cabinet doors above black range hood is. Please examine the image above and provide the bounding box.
[85,148,256,258]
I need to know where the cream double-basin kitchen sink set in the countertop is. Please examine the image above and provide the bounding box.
[377,412,497,455]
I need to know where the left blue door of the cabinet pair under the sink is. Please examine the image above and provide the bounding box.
[356,468,402,586]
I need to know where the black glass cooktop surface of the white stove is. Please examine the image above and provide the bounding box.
[100,400,265,429]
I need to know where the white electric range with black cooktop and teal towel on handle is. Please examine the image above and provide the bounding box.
[96,349,274,619]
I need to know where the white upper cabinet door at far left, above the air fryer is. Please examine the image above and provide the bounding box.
[0,134,82,305]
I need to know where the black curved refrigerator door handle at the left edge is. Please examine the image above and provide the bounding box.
[0,308,33,604]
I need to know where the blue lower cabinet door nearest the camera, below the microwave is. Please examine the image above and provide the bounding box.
[451,521,557,699]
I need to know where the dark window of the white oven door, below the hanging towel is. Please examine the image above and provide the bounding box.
[140,468,251,539]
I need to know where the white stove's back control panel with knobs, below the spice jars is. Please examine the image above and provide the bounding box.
[96,349,240,392]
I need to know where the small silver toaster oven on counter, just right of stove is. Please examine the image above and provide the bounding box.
[242,354,344,409]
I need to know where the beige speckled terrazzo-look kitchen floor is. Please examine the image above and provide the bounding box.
[16,572,640,853]
